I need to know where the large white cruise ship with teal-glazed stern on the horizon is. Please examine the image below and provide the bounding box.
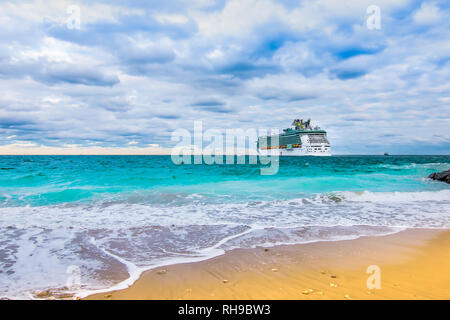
[258,119,331,156]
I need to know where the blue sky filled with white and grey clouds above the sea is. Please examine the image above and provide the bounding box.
[0,0,450,154]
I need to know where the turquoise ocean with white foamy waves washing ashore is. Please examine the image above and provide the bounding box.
[0,156,450,299]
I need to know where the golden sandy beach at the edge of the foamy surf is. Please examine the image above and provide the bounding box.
[87,229,450,300]
